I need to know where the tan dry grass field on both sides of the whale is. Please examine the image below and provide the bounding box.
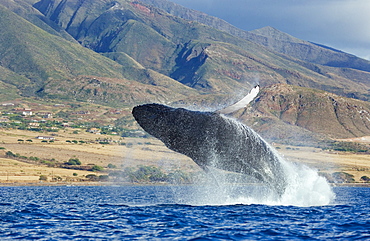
[0,129,370,183]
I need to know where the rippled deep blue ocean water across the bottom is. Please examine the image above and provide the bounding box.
[0,186,370,240]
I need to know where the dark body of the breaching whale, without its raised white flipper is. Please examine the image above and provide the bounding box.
[132,100,286,196]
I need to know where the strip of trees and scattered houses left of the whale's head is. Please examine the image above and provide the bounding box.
[0,100,146,137]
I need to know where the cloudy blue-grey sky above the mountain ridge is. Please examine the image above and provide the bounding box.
[170,0,370,60]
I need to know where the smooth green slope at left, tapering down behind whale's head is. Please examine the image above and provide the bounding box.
[0,1,197,104]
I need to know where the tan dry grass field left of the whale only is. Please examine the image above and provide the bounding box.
[0,129,199,183]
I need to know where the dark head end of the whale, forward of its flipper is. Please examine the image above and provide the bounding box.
[132,104,218,154]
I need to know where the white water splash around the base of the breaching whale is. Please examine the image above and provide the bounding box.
[172,128,335,207]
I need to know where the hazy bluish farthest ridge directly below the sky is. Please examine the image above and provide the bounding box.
[141,0,370,72]
